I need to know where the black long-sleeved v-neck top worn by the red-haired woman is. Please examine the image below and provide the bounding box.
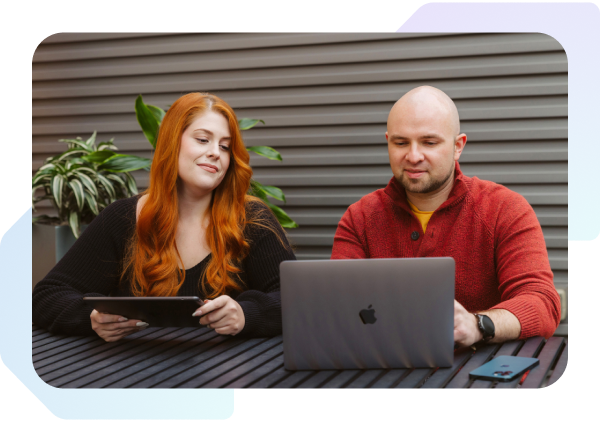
[33,195,296,337]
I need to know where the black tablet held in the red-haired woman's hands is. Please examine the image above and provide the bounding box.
[83,297,204,327]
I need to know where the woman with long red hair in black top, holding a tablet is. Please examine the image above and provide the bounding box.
[33,93,295,342]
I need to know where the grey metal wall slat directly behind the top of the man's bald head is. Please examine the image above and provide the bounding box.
[32,74,568,117]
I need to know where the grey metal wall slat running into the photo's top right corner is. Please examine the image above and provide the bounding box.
[31,34,564,81]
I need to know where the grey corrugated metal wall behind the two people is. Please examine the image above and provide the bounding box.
[32,33,568,333]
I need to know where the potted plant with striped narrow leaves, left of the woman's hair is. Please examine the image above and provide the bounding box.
[31,132,151,262]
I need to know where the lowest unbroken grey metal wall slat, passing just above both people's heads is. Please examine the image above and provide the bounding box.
[32,52,567,99]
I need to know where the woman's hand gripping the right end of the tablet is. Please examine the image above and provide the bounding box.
[193,295,246,335]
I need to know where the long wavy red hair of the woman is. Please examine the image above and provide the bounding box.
[121,92,259,298]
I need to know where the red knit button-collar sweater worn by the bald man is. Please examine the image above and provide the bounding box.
[331,162,560,339]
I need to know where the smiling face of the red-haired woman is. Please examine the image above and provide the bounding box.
[179,111,231,195]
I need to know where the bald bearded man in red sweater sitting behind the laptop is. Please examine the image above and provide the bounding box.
[331,86,560,346]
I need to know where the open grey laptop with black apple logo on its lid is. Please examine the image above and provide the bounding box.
[280,257,454,370]
